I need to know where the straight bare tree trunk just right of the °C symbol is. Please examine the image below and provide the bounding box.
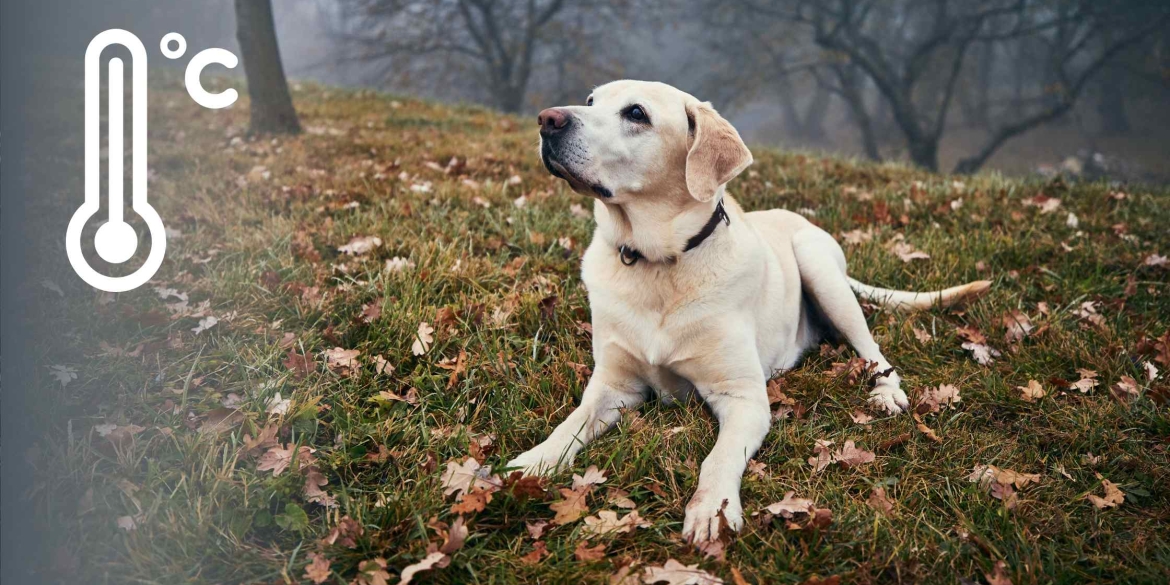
[235,0,301,133]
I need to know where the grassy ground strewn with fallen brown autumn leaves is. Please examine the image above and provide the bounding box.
[18,77,1170,584]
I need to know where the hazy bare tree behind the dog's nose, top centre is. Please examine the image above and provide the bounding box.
[337,0,628,112]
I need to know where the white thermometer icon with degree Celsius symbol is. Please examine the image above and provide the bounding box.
[66,28,238,293]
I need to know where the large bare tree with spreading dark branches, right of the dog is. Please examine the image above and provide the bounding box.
[730,0,1170,173]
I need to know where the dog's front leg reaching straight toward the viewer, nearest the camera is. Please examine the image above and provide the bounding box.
[682,376,772,544]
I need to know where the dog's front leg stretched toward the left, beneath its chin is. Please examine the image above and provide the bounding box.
[508,364,646,475]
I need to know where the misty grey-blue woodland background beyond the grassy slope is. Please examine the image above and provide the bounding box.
[29,0,1170,183]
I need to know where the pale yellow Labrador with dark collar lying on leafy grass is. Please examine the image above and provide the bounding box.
[508,81,990,544]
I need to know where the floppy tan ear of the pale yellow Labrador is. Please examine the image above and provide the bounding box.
[687,102,751,201]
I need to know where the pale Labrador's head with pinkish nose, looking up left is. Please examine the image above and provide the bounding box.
[537,81,751,204]
